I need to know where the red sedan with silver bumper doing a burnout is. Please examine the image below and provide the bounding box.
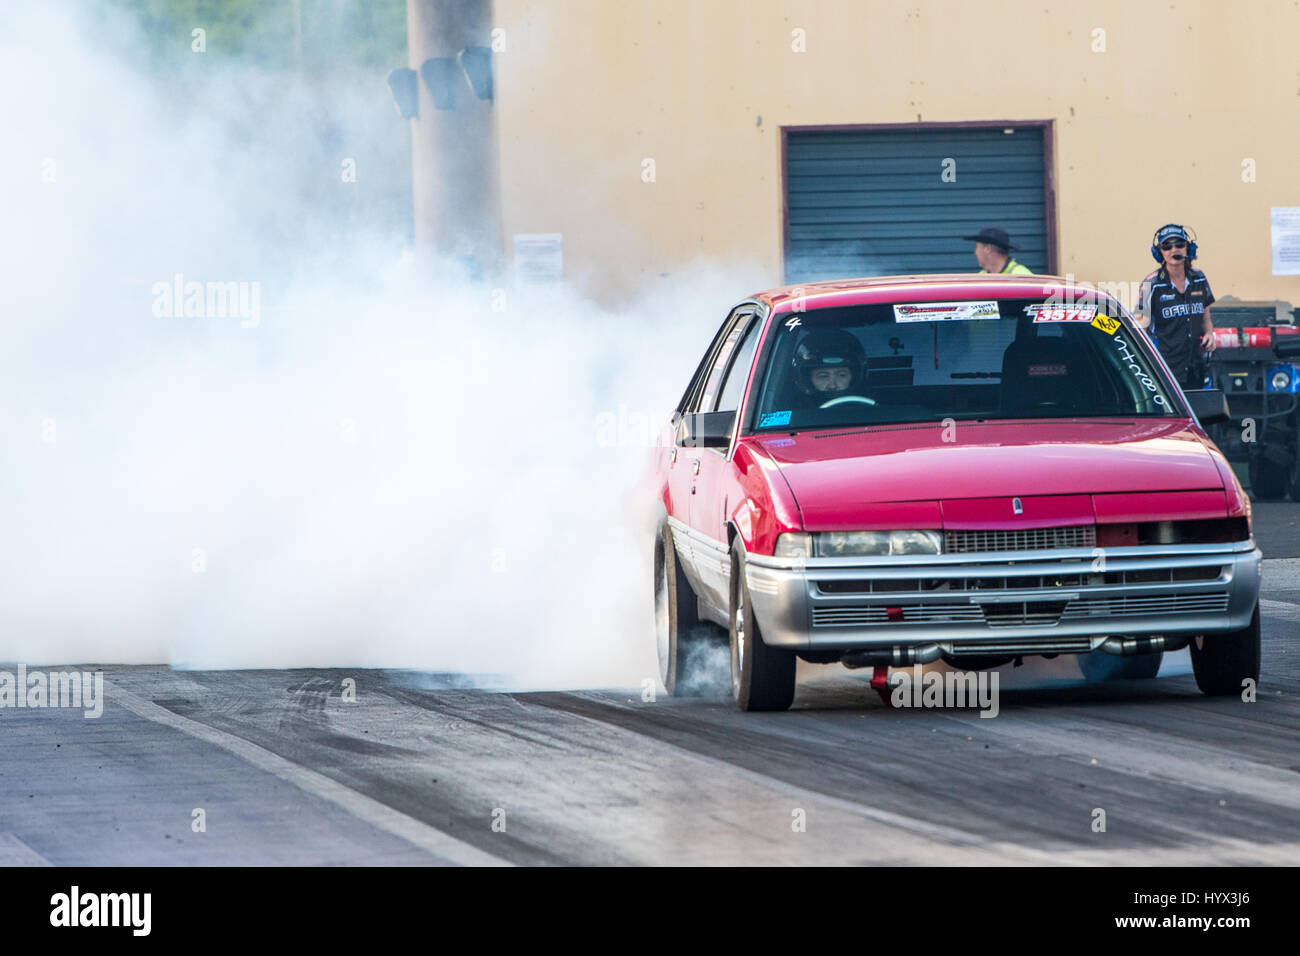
[654,276,1261,710]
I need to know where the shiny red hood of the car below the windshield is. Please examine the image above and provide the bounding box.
[748,419,1223,520]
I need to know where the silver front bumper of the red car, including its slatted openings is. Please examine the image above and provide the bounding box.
[745,541,1261,653]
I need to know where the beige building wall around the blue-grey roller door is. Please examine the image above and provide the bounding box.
[494,0,1300,304]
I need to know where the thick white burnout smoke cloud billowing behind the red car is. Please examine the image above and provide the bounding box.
[0,4,771,687]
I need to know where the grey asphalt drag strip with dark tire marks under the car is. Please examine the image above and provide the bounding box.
[0,546,1300,865]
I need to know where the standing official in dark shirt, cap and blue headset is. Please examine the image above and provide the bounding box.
[1135,222,1214,390]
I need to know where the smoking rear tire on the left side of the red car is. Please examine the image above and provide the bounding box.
[654,519,727,697]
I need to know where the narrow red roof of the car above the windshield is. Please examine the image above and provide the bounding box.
[753,273,1109,312]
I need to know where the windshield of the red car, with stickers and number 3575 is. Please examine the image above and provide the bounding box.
[753,297,1183,431]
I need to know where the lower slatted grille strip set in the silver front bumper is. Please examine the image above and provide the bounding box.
[813,592,1227,627]
